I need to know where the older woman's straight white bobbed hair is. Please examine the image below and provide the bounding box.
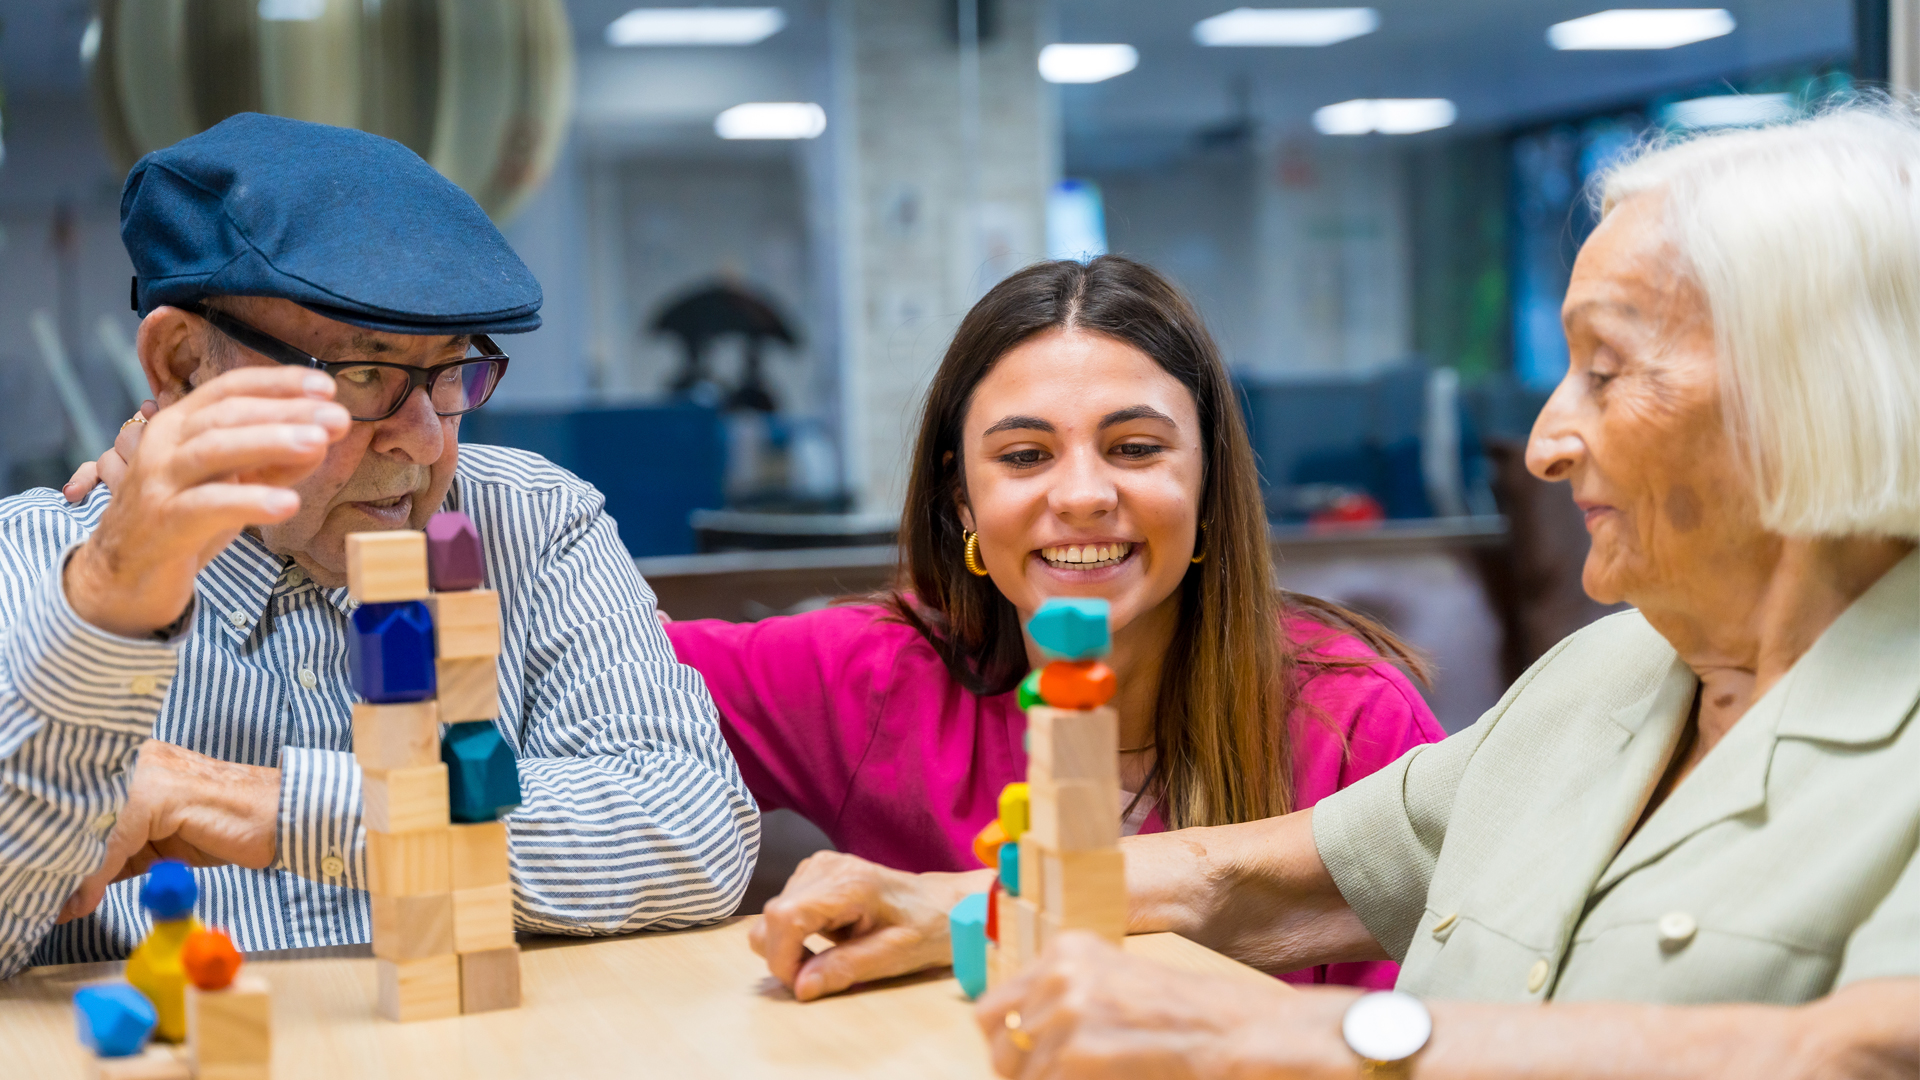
[1599,98,1920,538]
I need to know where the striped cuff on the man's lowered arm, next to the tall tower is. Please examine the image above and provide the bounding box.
[275,746,367,888]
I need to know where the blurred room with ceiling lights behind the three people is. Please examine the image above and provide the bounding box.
[0,0,1916,749]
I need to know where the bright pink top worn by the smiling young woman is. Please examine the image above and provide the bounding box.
[666,605,1444,986]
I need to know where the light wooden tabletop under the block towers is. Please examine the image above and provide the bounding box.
[0,919,1273,1080]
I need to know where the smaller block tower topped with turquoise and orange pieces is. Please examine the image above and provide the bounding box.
[954,598,1127,997]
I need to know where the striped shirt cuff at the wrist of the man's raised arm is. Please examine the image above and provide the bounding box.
[4,544,187,738]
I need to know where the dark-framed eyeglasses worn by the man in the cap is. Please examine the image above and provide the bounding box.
[188,304,507,421]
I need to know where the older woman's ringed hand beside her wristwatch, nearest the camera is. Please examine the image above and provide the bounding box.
[973,932,1359,1080]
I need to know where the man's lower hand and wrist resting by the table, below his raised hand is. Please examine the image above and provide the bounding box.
[60,738,280,922]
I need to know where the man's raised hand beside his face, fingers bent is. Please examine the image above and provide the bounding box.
[65,367,351,638]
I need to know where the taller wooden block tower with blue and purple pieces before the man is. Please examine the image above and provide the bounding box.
[348,513,520,1020]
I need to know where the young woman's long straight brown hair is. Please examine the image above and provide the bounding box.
[885,256,1425,828]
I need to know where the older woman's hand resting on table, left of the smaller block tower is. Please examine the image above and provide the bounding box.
[747,851,993,1001]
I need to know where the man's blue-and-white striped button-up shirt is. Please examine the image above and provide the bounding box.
[0,446,760,976]
